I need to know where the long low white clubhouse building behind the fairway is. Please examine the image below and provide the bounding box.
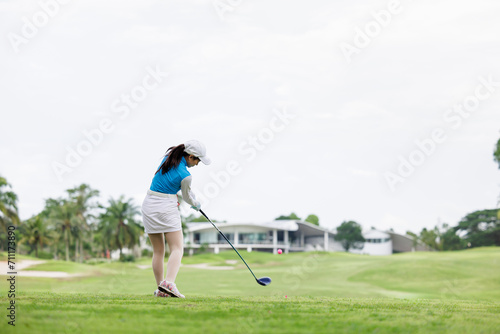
[184,220,431,255]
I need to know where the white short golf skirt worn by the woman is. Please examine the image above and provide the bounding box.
[141,190,182,234]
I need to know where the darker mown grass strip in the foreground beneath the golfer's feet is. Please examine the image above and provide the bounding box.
[0,293,500,334]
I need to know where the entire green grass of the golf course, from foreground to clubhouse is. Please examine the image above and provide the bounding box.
[0,248,500,333]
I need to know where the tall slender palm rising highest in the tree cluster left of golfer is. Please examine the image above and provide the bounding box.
[66,184,99,262]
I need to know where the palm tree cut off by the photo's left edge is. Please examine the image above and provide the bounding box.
[0,176,19,251]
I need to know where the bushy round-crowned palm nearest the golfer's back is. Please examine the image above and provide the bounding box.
[99,196,143,258]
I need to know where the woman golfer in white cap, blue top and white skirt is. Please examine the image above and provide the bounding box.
[142,140,211,298]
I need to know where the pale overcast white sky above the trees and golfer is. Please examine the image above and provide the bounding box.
[0,0,500,233]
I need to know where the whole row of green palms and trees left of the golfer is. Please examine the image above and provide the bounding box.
[0,180,143,262]
